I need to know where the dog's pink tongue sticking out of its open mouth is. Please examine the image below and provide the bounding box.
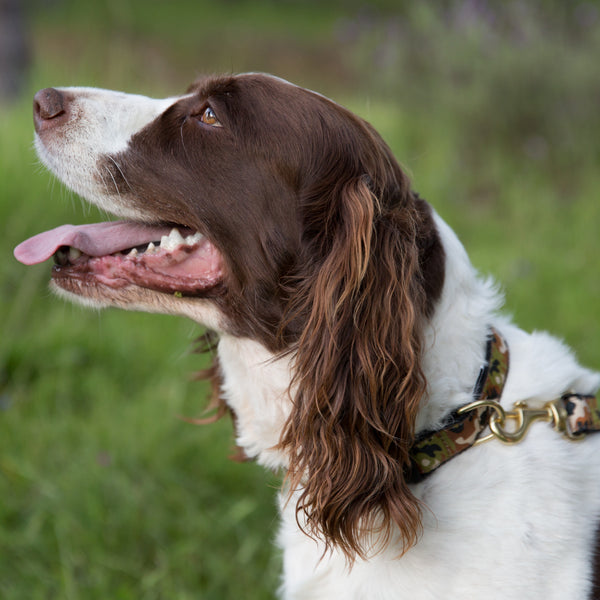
[14,221,171,265]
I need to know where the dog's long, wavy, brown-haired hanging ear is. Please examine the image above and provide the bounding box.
[281,168,443,560]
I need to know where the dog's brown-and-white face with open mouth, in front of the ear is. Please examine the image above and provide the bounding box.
[22,75,408,346]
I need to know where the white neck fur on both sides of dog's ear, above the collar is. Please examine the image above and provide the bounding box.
[218,215,500,468]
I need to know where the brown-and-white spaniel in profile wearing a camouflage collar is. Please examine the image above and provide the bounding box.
[15,74,600,600]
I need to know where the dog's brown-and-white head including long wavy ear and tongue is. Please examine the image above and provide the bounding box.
[16,74,444,554]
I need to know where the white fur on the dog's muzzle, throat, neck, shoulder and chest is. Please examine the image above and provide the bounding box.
[38,81,600,600]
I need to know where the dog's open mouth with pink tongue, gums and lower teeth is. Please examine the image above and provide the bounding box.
[14,221,223,296]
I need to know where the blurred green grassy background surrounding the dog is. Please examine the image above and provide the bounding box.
[0,0,600,600]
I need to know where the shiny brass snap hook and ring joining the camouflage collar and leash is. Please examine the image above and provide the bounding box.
[458,399,585,445]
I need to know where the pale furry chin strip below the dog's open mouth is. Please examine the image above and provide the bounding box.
[50,277,227,332]
